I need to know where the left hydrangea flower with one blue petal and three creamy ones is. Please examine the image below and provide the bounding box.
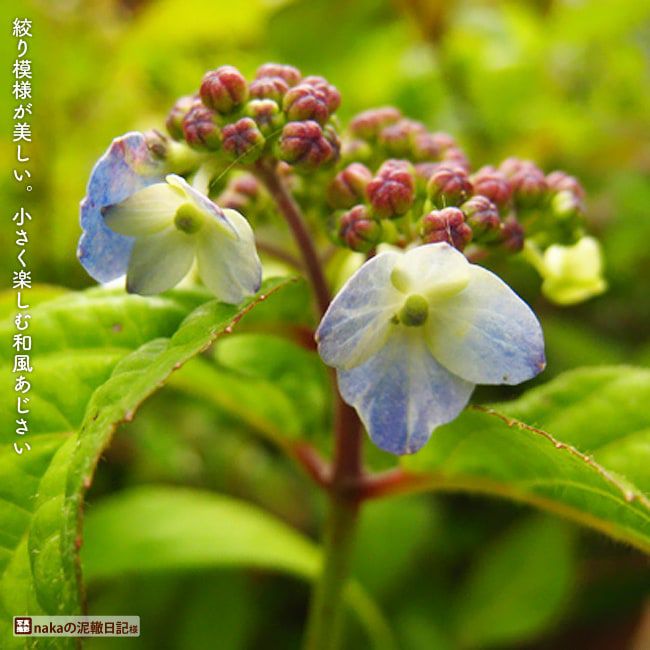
[79,134,262,304]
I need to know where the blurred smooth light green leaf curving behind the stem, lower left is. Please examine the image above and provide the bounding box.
[82,486,392,648]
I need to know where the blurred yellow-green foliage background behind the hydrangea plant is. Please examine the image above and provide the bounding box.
[0,0,650,650]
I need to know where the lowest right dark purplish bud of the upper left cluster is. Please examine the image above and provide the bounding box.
[277,120,336,169]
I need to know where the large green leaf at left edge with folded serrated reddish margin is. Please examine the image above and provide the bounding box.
[0,280,287,647]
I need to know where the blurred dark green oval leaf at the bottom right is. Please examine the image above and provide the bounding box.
[456,515,573,648]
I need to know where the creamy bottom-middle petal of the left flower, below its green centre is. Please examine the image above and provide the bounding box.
[126,227,194,295]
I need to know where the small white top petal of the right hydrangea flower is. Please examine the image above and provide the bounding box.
[392,243,470,299]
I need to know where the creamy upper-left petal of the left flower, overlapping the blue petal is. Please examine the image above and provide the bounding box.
[102,183,185,237]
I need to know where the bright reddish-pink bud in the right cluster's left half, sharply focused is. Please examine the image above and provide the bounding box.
[366,160,415,219]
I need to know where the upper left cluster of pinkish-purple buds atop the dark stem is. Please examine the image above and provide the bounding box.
[161,63,341,171]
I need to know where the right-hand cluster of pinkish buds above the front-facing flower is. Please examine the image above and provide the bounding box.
[326,107,584,255]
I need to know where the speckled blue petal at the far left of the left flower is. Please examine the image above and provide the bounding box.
[77,132,164,282]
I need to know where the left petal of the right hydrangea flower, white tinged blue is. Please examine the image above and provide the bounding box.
[316,253,404,369]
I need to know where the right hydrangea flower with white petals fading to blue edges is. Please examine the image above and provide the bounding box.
[316,243,545,454]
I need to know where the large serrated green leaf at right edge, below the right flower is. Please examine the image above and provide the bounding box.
[403,366,650,552]
